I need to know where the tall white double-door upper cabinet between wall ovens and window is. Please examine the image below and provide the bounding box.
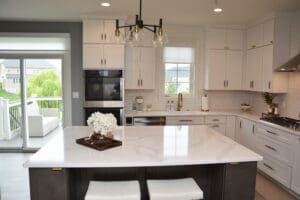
[125,47,156,90]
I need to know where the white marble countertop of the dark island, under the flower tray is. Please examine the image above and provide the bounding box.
[24,125,262,168]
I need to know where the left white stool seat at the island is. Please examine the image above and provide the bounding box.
[85,181,141,200]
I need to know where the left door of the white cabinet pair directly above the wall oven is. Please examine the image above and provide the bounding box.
[83,44,103,69]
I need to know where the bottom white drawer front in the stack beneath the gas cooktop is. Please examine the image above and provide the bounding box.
[257,154,292,188]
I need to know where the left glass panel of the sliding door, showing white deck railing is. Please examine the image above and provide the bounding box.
[0,58,23,149]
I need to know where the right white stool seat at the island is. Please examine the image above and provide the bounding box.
[147,178,203,200]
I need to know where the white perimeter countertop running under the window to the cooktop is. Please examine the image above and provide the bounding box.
[125,110,300,136]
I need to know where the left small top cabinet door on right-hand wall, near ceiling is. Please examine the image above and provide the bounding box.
[247,24,263,49]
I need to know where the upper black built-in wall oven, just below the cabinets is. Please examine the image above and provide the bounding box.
[85,70,124,108]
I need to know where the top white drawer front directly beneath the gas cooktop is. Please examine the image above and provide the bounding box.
[255,124,292,144]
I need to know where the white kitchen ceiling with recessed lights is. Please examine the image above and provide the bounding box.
[0,0,300,25]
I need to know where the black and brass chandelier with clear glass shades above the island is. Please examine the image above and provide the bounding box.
[115,0,167,47]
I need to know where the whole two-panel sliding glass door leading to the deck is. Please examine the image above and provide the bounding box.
[0,55,63,150]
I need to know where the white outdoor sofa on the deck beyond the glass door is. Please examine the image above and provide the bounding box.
[27,101,59,137]
